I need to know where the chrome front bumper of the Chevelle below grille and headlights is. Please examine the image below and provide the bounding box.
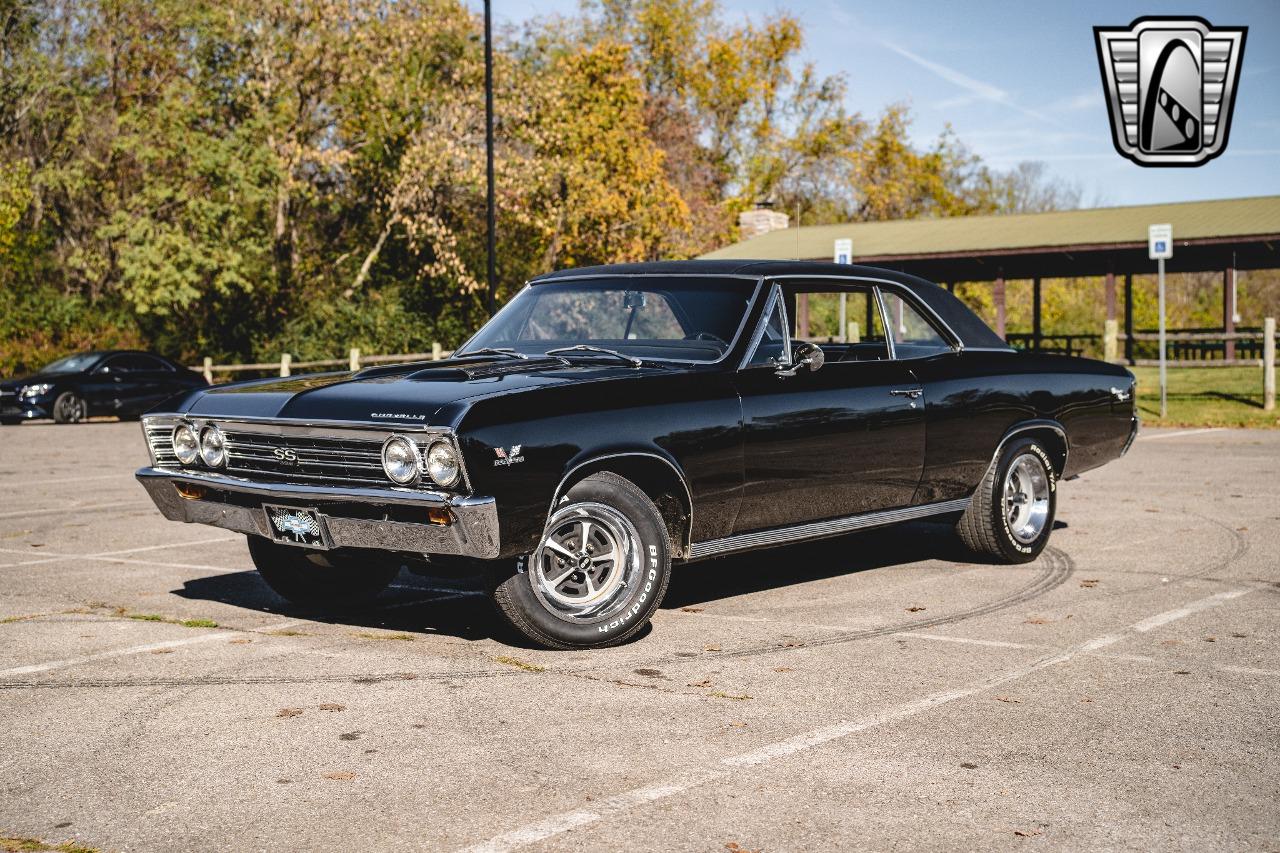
[136,467,500,560]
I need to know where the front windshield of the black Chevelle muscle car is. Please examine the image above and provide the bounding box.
[456,275,754,361]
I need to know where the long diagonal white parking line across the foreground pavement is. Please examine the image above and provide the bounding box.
[466,589,1253,853]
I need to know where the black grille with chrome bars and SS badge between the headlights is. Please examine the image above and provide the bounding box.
[223,424,388,485]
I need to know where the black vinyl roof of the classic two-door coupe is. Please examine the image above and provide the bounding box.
[530,259,1010,350]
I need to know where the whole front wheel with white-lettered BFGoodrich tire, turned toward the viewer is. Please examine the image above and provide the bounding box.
[494,473,671,649]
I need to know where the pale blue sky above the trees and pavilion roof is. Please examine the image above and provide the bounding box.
[493,0,1280,205]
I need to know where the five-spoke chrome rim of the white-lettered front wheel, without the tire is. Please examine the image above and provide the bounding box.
[530,501,640,619]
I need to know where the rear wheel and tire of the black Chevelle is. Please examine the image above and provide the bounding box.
[956,438,1057,564]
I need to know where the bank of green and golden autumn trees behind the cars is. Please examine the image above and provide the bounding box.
[0,0,1095,373]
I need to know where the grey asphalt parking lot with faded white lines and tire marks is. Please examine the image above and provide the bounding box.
[0,423,1280,850]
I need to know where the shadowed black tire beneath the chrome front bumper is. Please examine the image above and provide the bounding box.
[248,537,399,611]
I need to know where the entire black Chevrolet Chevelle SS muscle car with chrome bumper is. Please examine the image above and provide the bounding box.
[138,261,1138,648]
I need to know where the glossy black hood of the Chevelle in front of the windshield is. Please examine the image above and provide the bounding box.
[187,359,686,427]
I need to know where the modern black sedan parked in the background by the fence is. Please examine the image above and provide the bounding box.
[0,350,209,425]
